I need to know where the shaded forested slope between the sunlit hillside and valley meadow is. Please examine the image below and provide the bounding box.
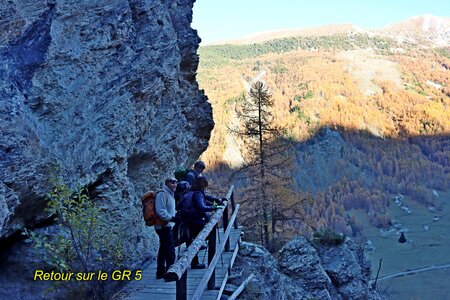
[207,127,450,237]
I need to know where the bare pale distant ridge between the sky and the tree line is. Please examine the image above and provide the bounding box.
[208,14,450,47]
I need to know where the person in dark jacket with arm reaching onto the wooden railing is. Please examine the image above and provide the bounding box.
[178,176,222,269]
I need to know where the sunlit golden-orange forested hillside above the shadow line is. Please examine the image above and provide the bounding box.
[198,35,450,162]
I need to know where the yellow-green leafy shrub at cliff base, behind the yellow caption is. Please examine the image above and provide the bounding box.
[24,178,128,299]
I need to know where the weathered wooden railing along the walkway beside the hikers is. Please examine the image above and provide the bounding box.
[164,186,239,300]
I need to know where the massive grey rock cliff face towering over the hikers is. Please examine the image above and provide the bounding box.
[0,0,214,296]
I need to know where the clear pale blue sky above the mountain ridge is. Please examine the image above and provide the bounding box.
[192,0,450,43]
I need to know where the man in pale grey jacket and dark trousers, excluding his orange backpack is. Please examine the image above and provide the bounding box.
[155,176,177,279]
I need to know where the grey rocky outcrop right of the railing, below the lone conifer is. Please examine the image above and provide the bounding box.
[234,237,383,299]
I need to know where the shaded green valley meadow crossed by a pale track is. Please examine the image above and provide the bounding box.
[360,191,450,299]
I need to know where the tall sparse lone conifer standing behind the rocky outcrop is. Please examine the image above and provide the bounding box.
[233,81,301,247]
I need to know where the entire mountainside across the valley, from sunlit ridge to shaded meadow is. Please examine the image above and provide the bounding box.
[198,16,450,299]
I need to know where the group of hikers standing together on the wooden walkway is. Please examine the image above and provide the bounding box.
[155,160,226,279]
